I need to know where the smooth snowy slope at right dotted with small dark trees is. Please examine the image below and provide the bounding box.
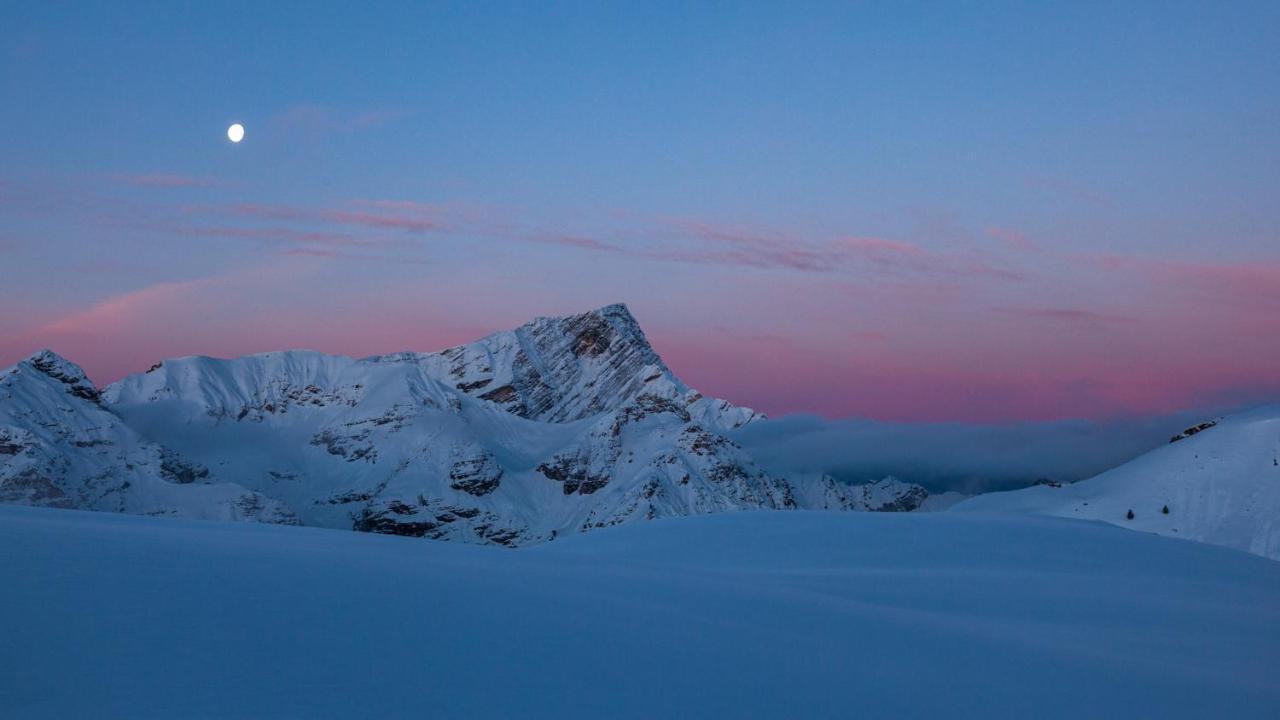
[952,406,1280,560]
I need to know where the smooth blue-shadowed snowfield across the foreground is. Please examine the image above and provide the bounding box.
[0,506,1280,717]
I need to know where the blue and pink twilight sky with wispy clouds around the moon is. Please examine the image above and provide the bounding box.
[0,3,1280,419]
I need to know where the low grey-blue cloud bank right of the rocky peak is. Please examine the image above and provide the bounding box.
[733,413,1239,495]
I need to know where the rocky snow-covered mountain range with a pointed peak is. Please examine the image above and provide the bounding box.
[0,305,927,546]
